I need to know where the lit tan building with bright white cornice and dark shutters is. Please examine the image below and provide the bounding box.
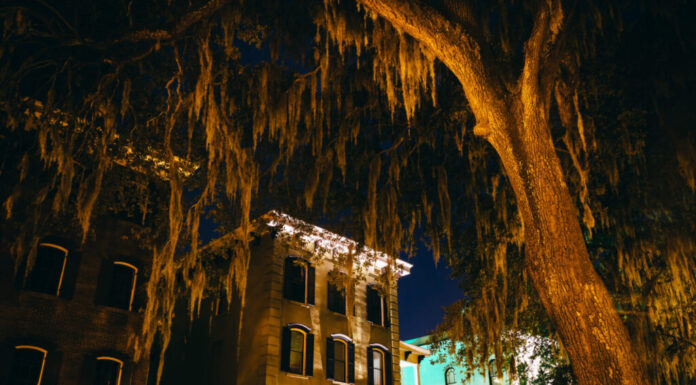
[163,213,411,385]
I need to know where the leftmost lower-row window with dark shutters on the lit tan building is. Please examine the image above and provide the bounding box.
[280,324,314,376]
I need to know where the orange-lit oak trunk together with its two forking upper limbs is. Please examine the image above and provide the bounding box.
[361,0,648,385]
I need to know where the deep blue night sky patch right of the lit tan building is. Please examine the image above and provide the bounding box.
[399,248,462,340]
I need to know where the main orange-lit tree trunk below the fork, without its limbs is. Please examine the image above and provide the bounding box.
[488,109,648,385]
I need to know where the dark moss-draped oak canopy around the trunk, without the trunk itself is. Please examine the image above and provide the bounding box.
[0,0,696,384]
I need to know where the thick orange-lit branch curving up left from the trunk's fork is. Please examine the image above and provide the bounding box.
[359,0,506,136]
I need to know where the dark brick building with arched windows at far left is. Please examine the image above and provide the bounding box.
[0,218,151,385]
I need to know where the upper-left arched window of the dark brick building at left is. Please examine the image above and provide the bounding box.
[26,243,68,295]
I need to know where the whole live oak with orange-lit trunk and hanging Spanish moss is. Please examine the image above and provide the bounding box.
[0,0,695,384]
